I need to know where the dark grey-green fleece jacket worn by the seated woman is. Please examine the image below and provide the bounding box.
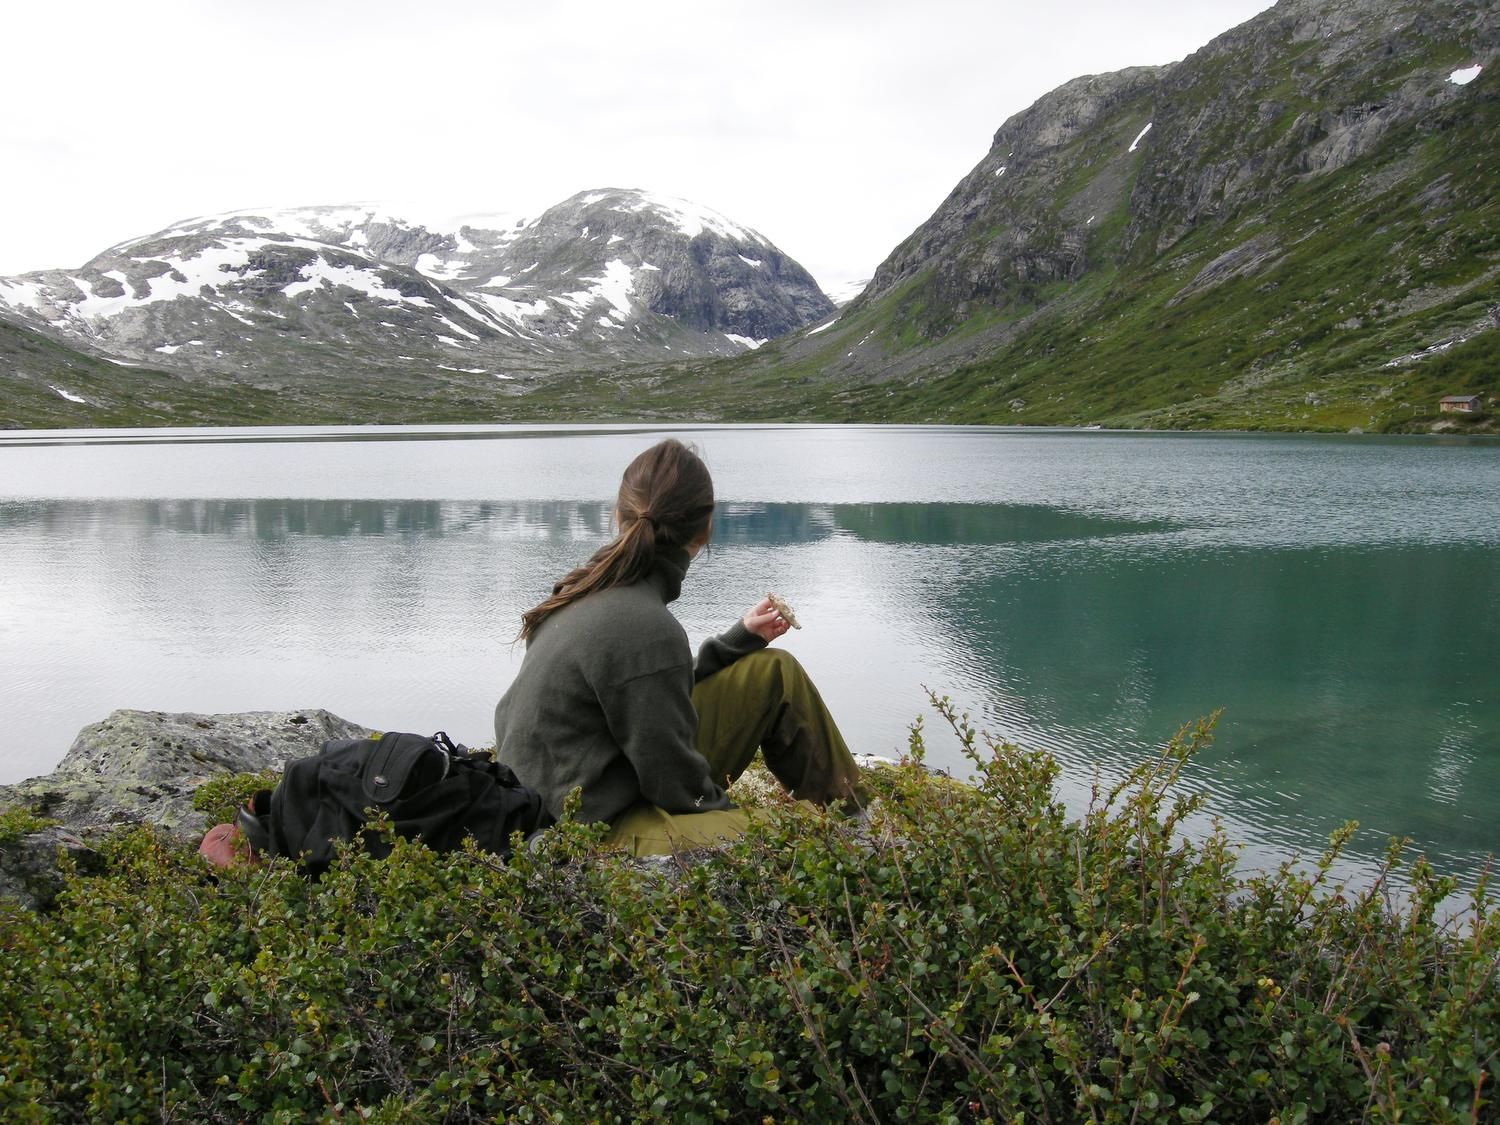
[495,551,765,821]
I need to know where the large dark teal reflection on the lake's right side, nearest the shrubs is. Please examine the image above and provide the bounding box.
[924,546,1500,870]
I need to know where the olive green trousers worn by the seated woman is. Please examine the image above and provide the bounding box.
[608,648,864,855]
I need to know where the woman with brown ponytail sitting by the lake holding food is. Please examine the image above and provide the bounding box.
[495,438,860,855]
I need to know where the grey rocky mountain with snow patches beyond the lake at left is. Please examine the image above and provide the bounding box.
[0,189,833,393]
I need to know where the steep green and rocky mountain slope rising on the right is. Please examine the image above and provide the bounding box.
[615,0,1500,431]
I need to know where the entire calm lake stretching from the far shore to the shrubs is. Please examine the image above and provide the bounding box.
[0,426,1500,900]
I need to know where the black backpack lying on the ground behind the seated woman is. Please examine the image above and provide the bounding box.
[236,731,542,876]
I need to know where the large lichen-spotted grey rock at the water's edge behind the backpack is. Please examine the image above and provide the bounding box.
[0,711,371,840]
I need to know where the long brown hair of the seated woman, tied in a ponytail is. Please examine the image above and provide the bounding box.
[521,438,714,641]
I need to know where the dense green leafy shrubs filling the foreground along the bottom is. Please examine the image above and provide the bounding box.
[0,701,1500,1122]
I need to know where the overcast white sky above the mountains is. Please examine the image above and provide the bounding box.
[0,0,1269,295]
